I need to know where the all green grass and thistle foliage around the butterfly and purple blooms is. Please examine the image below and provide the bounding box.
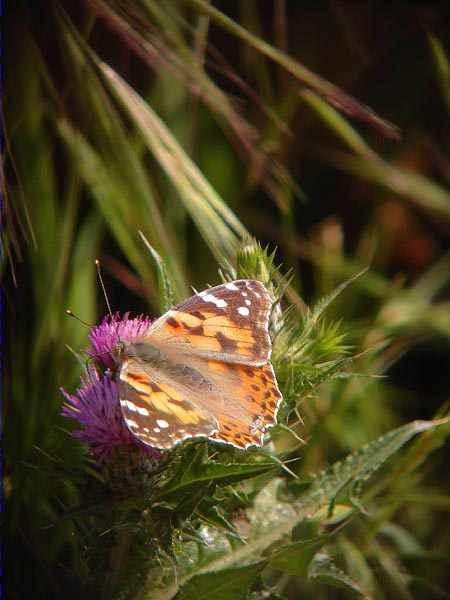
[2,0,450,600]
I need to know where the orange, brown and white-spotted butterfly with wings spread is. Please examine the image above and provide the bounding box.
[115,279,282,450]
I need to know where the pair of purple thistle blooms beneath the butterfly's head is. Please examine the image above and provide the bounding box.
[61,313,160,460]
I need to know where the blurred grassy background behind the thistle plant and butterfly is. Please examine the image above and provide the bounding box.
[2,0,450,598]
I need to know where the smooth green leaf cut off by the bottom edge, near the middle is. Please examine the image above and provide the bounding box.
[175,561,266,600]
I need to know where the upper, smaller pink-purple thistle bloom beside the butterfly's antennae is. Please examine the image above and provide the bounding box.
[88,313,152,369]
